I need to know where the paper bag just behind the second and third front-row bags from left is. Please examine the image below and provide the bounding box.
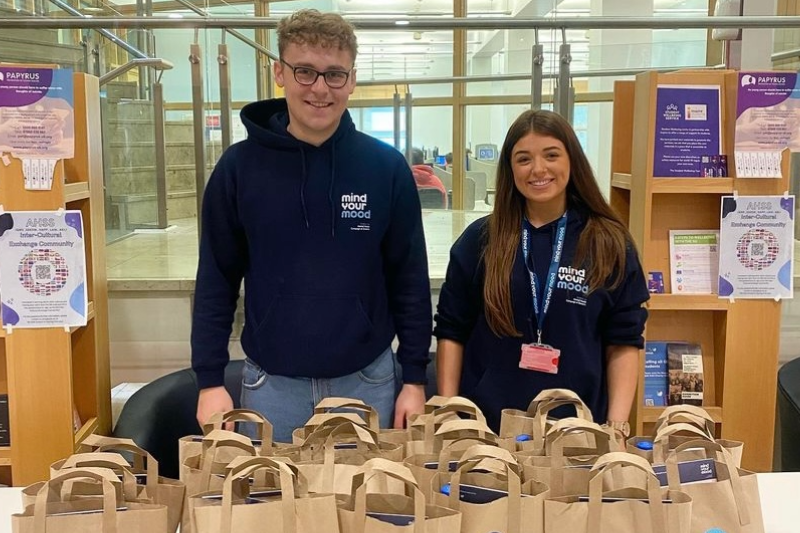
[278,422,404,494]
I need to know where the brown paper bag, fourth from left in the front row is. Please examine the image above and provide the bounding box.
[544,452,692,533]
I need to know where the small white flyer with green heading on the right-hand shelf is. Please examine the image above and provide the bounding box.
[669,229,719,294]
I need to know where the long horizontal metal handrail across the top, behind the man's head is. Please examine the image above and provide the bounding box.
[0,14,800,31]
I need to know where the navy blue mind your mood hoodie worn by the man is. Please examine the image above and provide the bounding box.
[192,99,432,388]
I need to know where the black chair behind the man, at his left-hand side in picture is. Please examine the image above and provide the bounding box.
[113,360,244,479]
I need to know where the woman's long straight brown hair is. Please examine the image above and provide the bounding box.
[483,110,632,337]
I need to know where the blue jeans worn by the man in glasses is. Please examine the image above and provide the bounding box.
[240,347,401,442]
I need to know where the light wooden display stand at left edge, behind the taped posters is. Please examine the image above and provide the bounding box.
[0,70,111,486]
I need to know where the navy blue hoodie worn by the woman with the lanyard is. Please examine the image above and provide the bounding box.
[434,210,650,430]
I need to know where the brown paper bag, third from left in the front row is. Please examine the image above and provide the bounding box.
[338,459,461,533]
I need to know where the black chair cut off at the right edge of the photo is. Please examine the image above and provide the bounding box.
[778,358,800,472]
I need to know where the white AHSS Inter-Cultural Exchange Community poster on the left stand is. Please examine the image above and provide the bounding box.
[0,211,88,328]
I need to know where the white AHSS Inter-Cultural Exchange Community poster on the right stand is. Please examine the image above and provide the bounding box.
[719,196,795,298]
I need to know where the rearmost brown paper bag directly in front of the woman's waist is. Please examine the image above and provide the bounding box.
[500,389,593,455]
